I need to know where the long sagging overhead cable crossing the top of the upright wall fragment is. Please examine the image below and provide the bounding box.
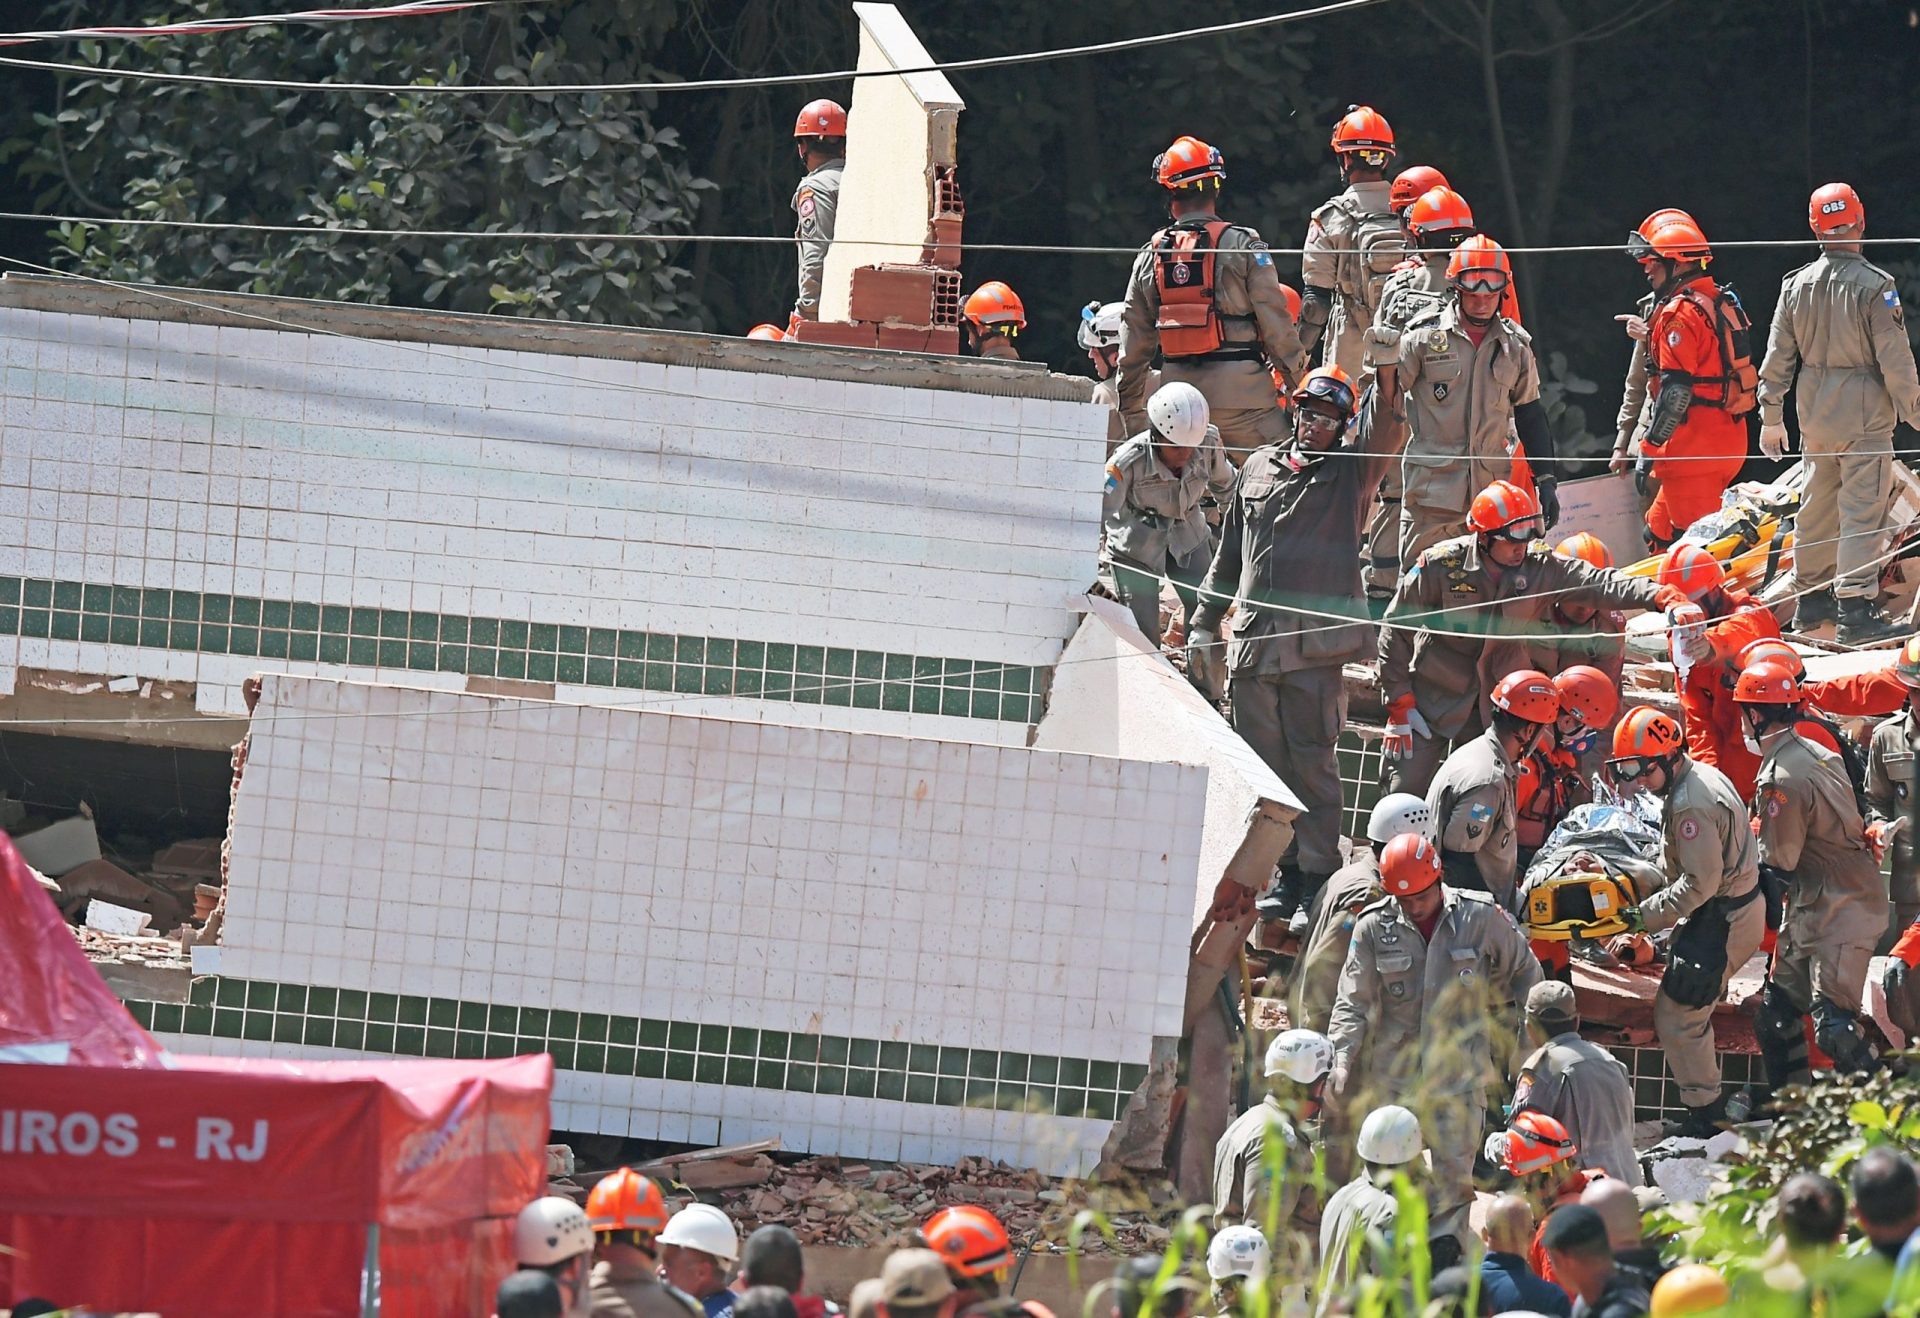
[0,0,1384,96]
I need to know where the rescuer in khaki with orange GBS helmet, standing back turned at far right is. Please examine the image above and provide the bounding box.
[1759,183,1920,646]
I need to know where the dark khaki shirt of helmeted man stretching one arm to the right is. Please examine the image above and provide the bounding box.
[1379,537,1663,738]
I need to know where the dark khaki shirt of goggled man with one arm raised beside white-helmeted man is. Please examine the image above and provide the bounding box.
[1192,392,1404,672]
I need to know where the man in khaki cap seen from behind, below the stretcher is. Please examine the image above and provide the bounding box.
[1513,980,1644,1185]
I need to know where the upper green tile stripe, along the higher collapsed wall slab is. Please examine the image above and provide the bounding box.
[0,576,1046,722]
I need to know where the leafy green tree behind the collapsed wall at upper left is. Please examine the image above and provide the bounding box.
[29,0,712,327]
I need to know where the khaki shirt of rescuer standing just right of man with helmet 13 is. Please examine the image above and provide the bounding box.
[1753,732,1887,945]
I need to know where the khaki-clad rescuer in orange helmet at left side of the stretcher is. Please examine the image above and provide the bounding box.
[1427,669,1559,911]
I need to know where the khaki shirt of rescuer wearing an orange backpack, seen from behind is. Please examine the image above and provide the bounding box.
[1114,225,1308,420]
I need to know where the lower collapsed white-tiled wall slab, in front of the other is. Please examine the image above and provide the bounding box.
[205,676,1208,1174]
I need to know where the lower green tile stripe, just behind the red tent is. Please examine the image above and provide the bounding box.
[127,976,1146,1120]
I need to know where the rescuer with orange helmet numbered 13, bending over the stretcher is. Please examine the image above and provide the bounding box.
[1607,705,1766,1137]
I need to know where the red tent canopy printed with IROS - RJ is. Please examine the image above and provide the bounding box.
[0,836,553,1318]
